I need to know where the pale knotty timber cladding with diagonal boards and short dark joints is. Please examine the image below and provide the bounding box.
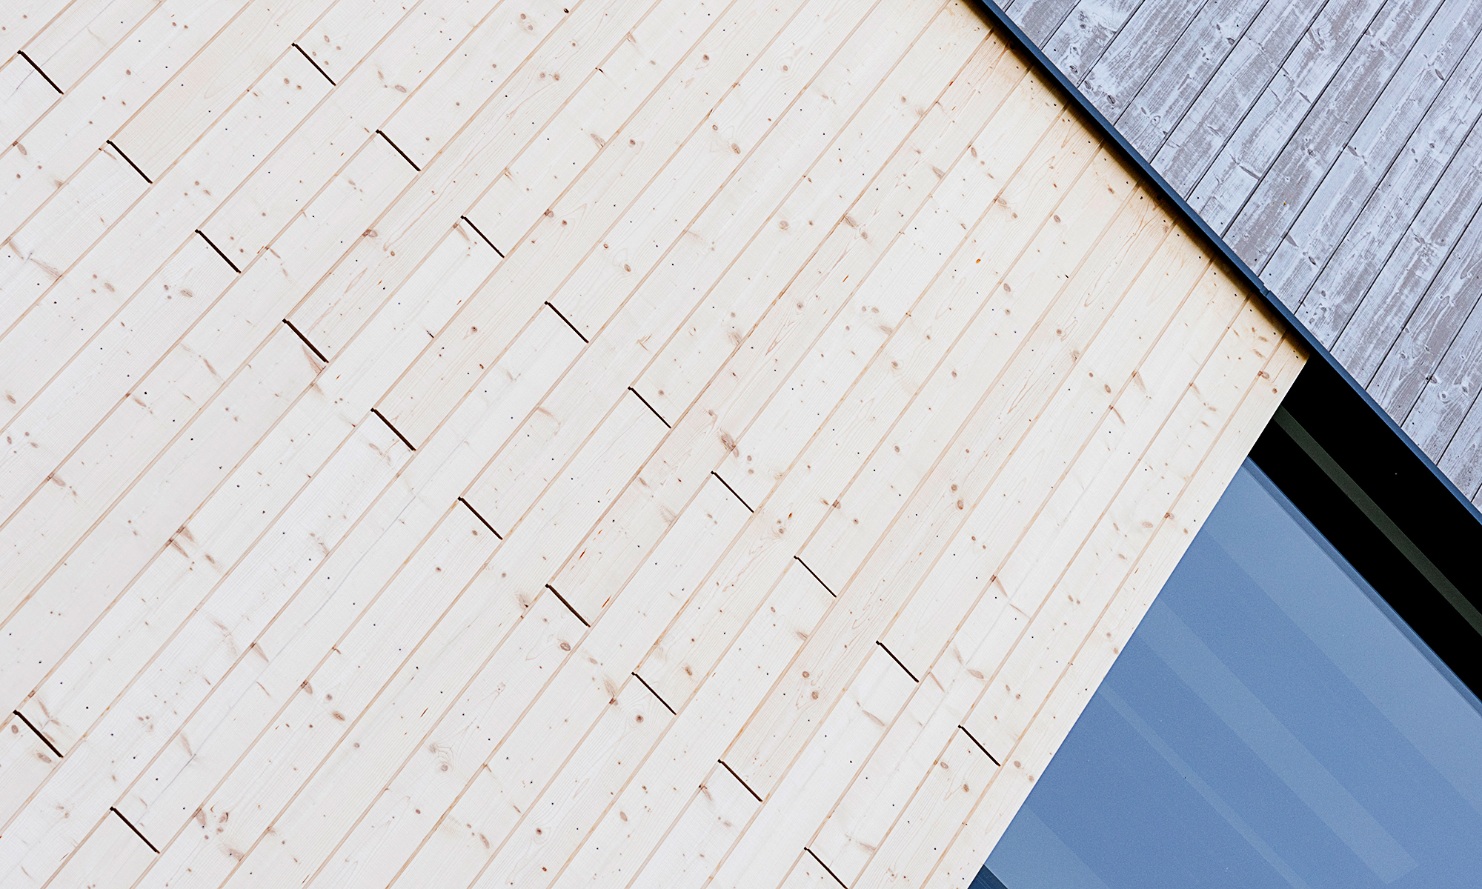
[0,0,1303,888]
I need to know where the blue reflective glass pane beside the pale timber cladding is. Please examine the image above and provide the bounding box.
[974,462,1482,889]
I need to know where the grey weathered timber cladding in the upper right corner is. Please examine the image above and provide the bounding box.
[1002,0,1482,502]
